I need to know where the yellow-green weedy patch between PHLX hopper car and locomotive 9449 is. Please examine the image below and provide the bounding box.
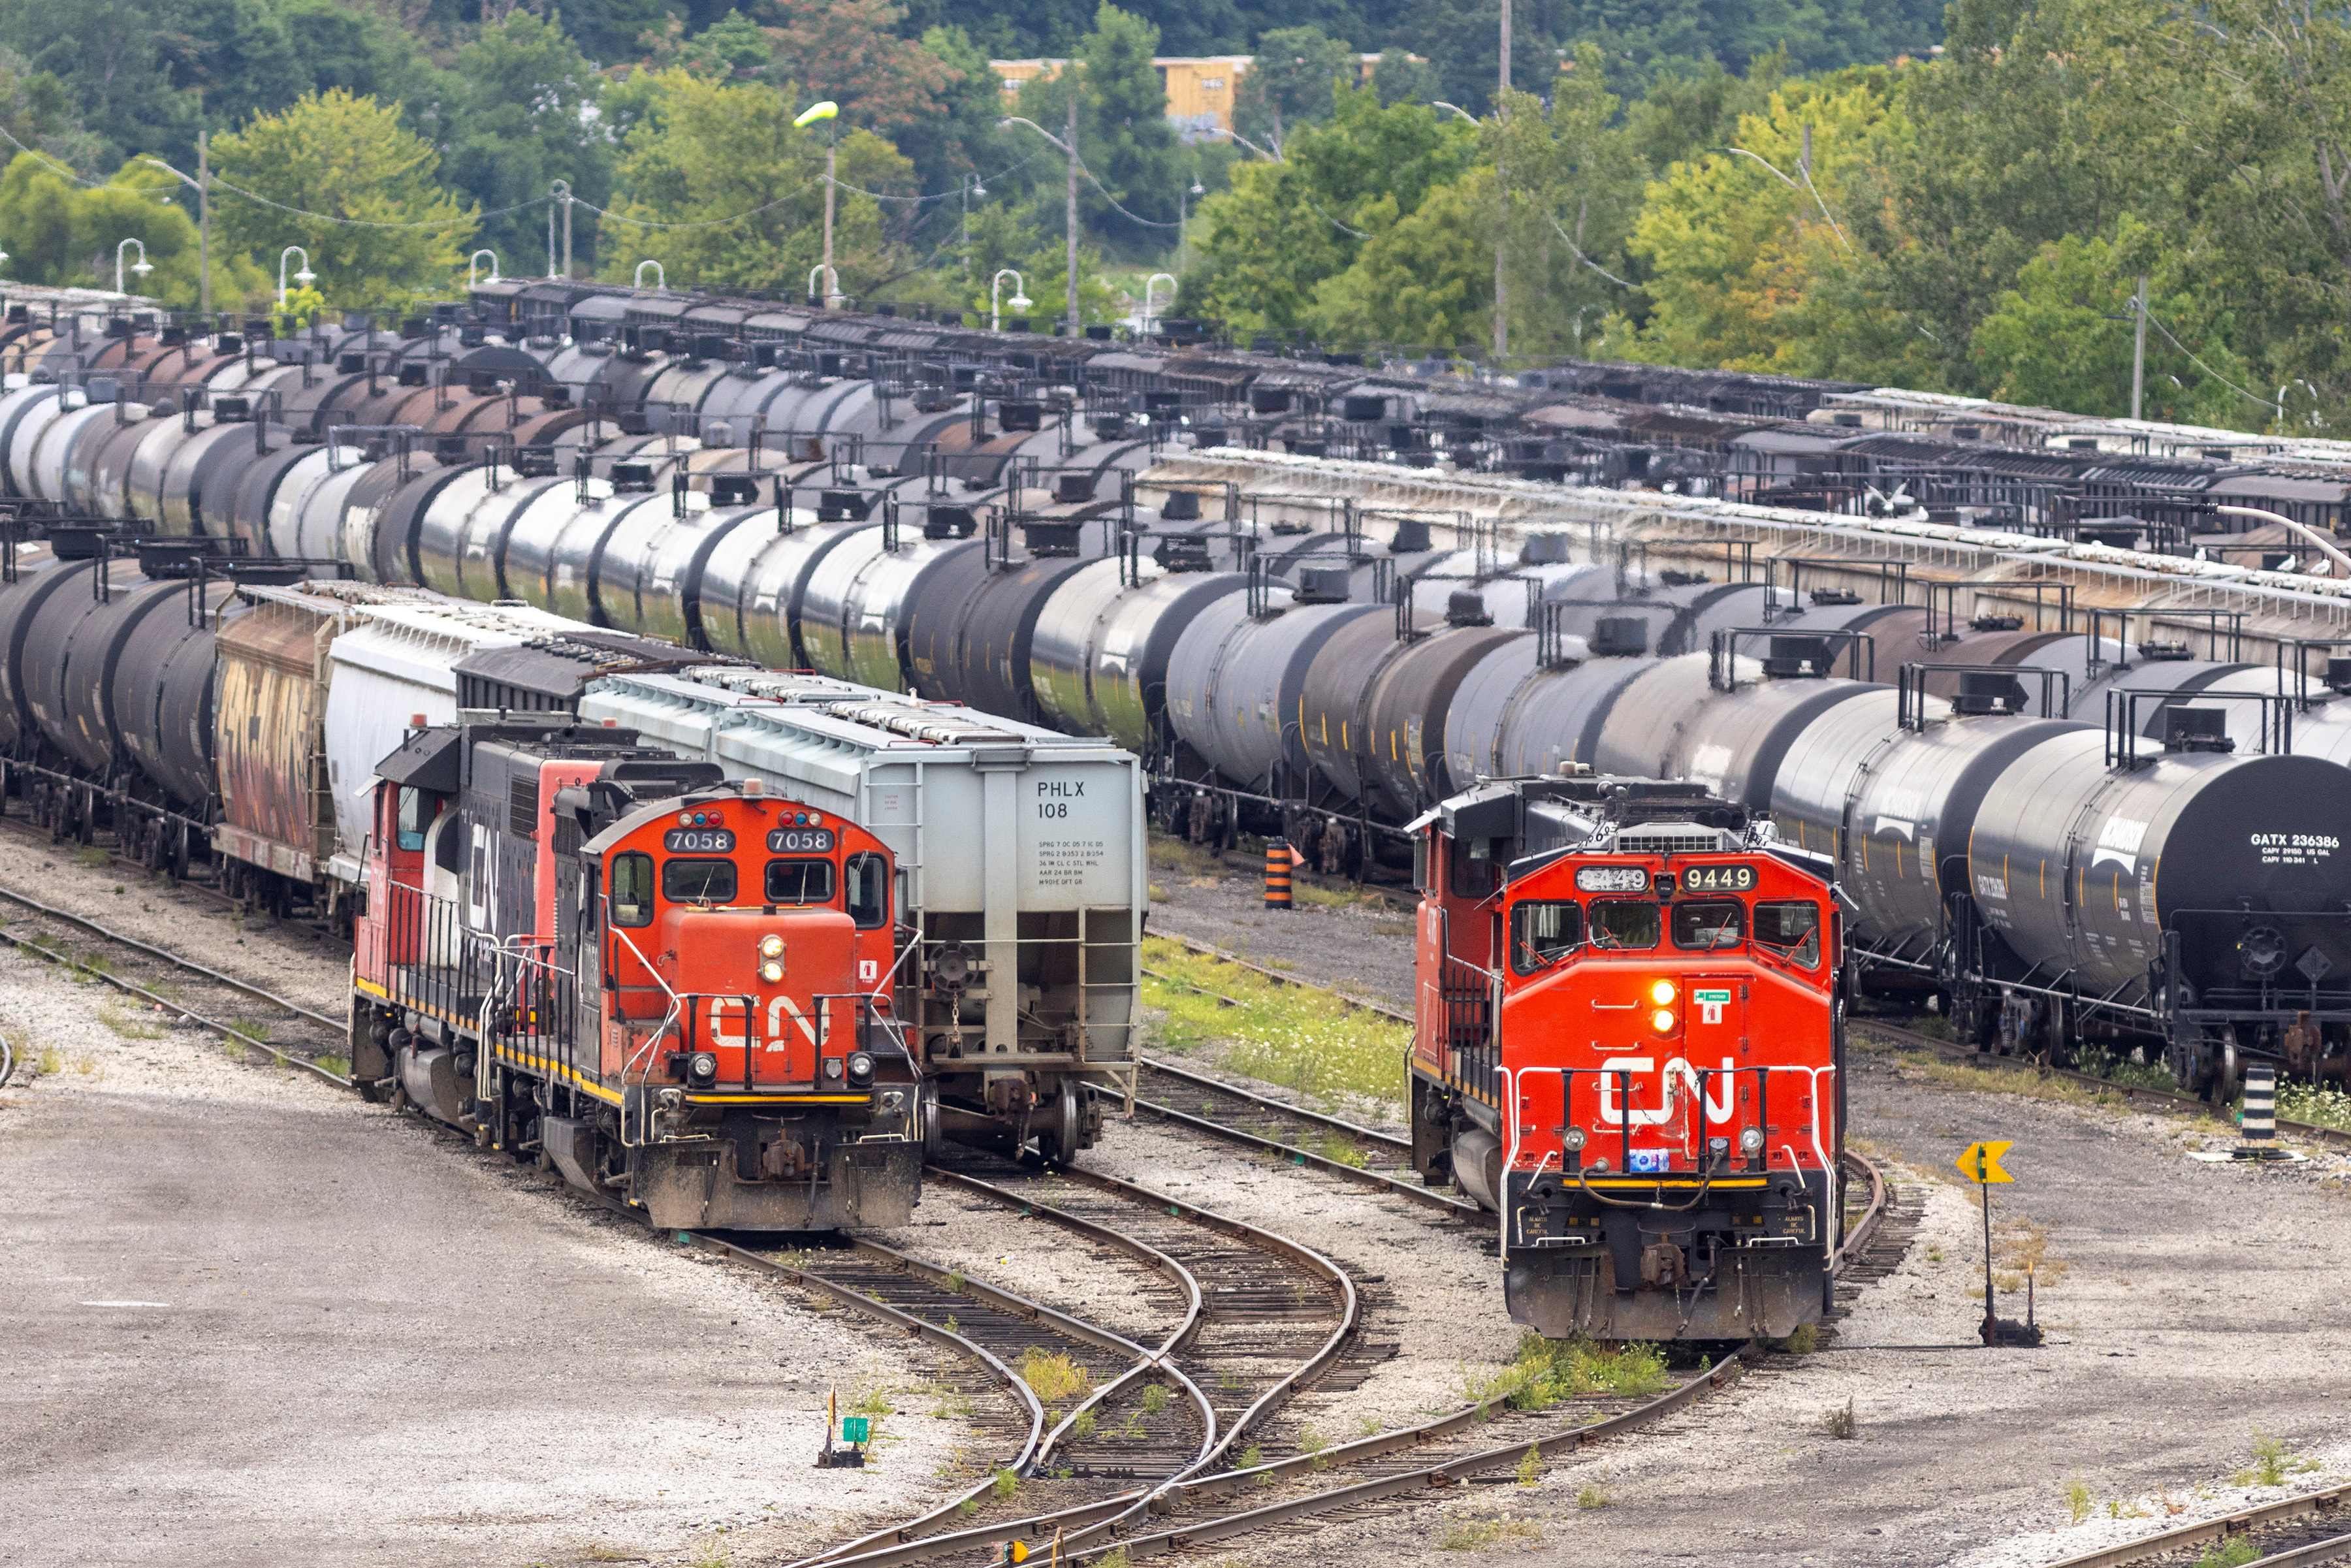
[1143,938,1413,1105]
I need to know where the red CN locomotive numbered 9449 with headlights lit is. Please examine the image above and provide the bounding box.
[1413,778,1846,1340]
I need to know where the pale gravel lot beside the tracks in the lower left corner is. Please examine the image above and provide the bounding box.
[0,940,973,1568]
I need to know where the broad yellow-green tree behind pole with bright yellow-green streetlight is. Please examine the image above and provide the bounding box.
[600,71,912,296]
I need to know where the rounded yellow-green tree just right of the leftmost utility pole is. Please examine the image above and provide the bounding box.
[212,87,475,308]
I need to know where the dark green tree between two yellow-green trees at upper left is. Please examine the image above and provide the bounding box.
[440,9,614,275]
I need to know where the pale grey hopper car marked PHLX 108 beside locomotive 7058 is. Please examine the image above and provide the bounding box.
[579,665,1149,1157]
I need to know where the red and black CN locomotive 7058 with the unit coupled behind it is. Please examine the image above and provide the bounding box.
[350,712,936,1230]
